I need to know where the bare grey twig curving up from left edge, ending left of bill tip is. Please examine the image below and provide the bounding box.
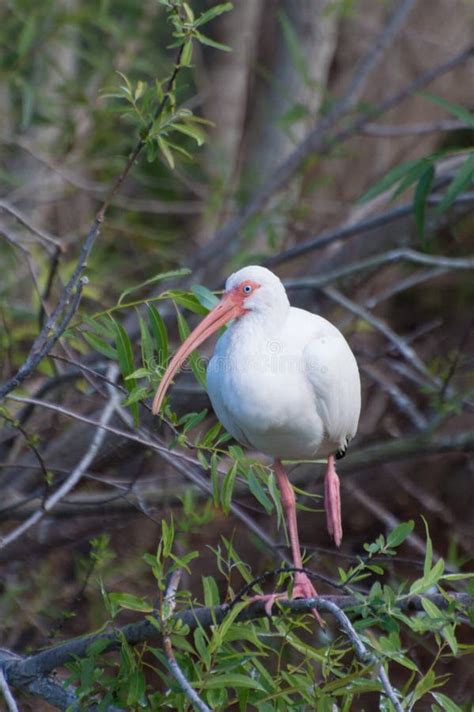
[0,364,119,549]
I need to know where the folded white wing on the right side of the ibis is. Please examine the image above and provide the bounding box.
[295,310,360,450]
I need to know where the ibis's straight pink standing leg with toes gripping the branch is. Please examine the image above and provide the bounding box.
[255,460,324,626]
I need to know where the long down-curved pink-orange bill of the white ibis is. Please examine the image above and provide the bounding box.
[151,292,244,415]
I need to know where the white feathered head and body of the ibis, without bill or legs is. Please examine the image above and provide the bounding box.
[207,267,360,459]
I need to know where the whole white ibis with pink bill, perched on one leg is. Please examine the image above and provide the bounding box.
[153,266,360,613]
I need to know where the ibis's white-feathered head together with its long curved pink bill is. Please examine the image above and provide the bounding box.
[152,265,288,415]
